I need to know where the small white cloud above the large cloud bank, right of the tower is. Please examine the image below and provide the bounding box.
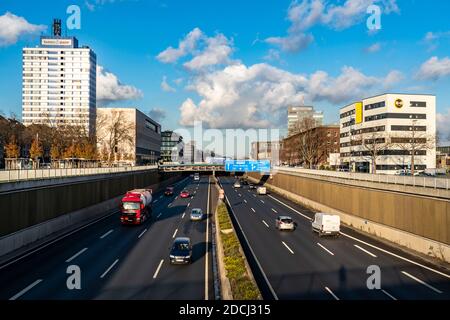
[156,28,234,71]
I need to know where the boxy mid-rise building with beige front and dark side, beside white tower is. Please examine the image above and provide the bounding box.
[97,108,161,165]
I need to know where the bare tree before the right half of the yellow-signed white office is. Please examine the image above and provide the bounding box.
[392,120,436,175]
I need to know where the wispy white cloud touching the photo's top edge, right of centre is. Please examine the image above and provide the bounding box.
[265,0,399,52]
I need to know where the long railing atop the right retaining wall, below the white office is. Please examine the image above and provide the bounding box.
[273,167,450,190]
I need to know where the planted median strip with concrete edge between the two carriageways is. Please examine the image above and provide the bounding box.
[214,178,262,300]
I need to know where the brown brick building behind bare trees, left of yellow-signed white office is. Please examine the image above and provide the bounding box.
[280,125,339,168]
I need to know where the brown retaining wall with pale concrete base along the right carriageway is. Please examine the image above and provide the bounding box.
[249,174,450,262]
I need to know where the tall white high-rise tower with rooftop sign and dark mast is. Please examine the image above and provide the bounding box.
[22,20,97,135]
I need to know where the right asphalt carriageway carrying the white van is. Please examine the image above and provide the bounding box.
[220,177,450,300]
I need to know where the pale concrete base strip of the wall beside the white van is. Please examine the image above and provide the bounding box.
[248,176,450,263]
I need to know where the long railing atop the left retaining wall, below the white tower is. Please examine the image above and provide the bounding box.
[0,165,158,183]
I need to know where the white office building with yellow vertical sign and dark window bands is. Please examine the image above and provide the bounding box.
[340,93,436,174]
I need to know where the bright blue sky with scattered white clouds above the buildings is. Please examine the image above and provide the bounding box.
[0,0,450,141]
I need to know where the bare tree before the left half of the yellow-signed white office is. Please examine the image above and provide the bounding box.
[358,132,392,174]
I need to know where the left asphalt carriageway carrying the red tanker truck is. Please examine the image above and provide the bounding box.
[0,176,213,300]
